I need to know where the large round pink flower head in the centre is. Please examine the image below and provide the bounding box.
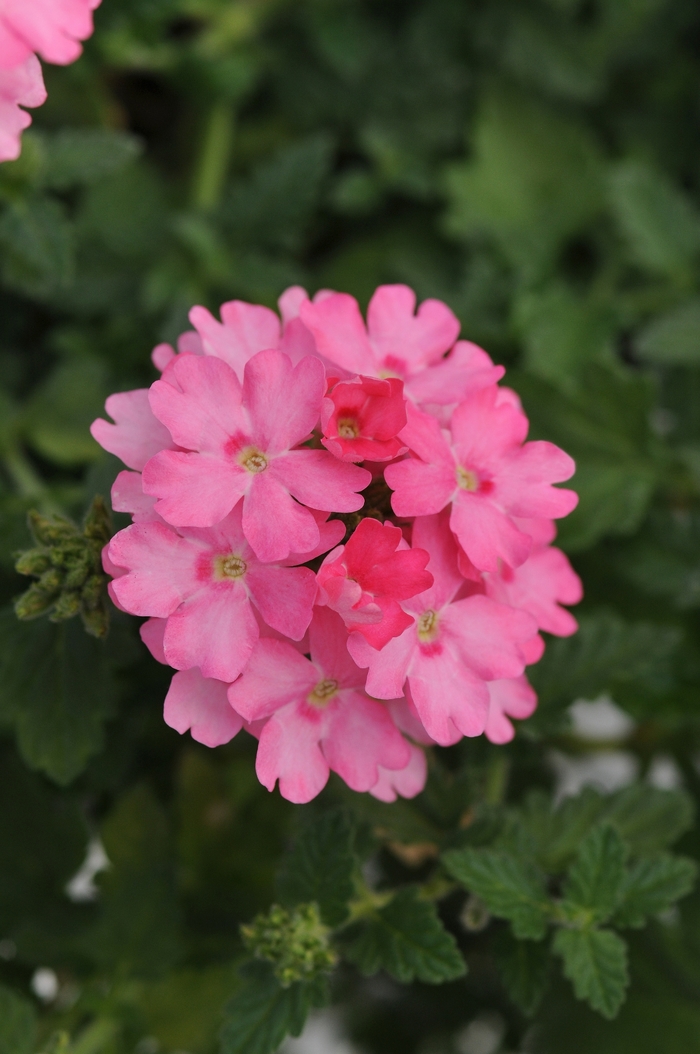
[92,286,581,802]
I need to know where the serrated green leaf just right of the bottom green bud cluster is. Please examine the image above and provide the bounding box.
[344,886,466,984]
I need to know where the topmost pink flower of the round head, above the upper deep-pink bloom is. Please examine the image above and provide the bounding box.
[298,286,505,404]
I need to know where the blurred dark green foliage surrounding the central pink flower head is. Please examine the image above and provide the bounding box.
[0,0,700,1054]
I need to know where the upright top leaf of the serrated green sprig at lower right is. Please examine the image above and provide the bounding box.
[562,823,627,922]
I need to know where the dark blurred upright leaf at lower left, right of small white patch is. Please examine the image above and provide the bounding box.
[89,786,180,977]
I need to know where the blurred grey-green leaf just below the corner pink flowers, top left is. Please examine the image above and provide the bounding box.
[41,129,141,190]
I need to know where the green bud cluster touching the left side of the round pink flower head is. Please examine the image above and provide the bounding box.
[15,495,112,637]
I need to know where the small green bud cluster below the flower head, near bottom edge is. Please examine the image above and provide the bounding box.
[240,903,337,988]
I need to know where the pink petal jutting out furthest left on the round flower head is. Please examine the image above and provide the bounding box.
[90,388,175,472]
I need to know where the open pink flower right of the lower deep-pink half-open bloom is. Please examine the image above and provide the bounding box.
[348,515,537,745]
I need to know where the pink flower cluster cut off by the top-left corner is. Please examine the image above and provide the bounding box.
[0,0,100,161]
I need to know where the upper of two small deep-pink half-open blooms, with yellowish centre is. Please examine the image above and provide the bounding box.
[320,377,406,462]
